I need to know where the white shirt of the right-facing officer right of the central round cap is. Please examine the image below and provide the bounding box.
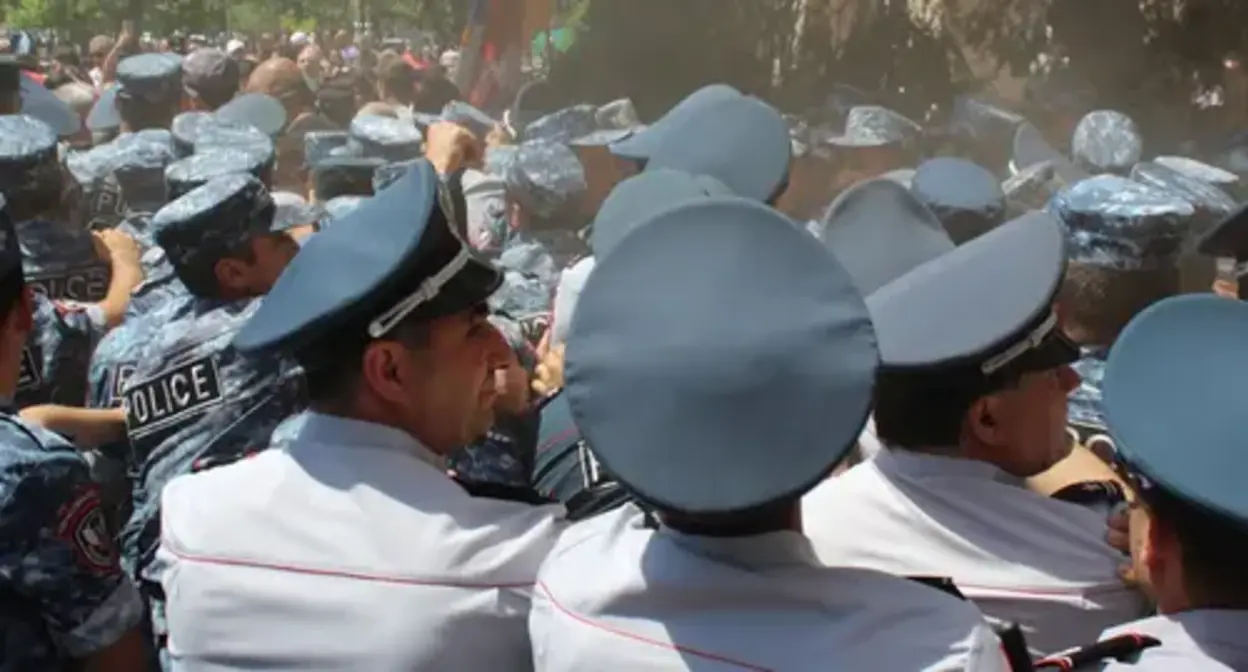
[802,448,1148,656]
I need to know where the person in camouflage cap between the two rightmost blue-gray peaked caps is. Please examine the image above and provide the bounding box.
[1052,175,1196,457]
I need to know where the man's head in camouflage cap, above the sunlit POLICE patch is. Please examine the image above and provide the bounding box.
[151,174,298,300]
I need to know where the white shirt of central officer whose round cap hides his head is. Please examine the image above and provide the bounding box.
[529,505,1008,672]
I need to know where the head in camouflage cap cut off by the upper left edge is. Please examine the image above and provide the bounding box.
[0,115,65,221]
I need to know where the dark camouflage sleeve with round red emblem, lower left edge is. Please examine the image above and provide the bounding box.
[0,442,142,658]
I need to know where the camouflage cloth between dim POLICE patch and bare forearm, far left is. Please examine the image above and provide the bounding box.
[16,294,106,408]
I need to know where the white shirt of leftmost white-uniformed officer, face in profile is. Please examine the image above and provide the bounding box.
[157,413,563,672]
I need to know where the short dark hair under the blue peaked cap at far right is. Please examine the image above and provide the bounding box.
[1141,488,1248,610]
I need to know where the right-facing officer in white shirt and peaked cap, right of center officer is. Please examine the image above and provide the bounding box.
[802,201,1144,653]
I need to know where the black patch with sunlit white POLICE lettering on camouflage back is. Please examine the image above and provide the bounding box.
[124,356,222,440]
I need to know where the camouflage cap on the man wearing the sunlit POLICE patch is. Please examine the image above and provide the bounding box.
[151,175,277,269]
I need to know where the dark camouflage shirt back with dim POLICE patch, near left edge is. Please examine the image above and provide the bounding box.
[16,219,112,304]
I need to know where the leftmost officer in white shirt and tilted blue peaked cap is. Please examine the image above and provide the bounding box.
[160,161,559,670]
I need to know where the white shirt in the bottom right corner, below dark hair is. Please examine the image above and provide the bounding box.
[1102,610,1248,672]
